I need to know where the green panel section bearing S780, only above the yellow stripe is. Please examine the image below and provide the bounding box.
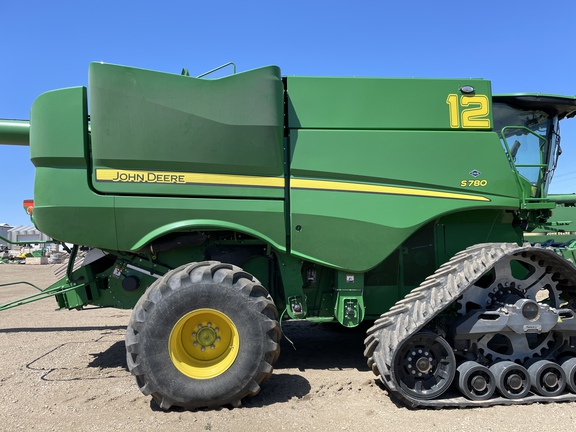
[290,130,518,197]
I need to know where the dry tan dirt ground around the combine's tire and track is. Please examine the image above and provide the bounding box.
[0,264,576,432]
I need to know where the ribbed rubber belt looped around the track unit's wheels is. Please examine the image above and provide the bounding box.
[364,243,576,408]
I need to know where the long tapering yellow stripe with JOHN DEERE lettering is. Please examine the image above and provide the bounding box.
[96,169,490,202]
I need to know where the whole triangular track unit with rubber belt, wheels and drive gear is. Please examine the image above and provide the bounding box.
[364,244,576,408]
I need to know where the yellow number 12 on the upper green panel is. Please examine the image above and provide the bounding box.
[446,93,490,129]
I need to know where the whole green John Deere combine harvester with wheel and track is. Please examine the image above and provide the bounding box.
[0,63,576,409]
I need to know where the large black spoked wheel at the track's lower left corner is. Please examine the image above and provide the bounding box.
[391,331,456,399]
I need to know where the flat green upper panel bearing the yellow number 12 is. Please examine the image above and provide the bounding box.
[287,77,492,130]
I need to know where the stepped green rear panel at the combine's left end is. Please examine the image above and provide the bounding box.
[30,87,117,249]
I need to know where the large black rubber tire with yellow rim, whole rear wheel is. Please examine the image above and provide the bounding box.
[126,261,281,410]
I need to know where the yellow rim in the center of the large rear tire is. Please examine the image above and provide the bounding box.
[168,309,240,379]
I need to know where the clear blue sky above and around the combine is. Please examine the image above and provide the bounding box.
[0,0,576,226]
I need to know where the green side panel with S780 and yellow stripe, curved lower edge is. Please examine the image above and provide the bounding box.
[290,130,519,271]
